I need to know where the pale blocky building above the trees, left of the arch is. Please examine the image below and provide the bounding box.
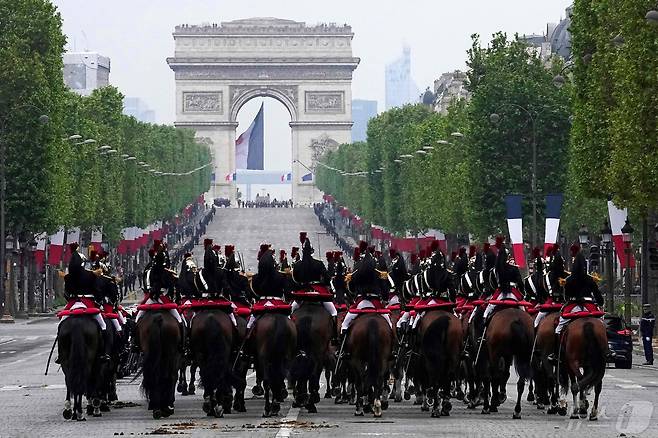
[62,52,110,96]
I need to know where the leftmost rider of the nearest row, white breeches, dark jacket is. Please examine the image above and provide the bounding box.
[55,242,112,364]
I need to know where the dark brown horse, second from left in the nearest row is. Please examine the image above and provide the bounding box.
[137,310,181,420]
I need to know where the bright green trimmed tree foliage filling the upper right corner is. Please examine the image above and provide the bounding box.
[569,0,658,216]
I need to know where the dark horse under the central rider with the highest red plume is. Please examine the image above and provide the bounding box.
[290,301,333,413]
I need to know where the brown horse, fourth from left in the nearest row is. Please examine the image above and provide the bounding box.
[250,313,297,417]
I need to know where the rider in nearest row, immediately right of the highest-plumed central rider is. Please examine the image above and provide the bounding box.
[340,241,393,337]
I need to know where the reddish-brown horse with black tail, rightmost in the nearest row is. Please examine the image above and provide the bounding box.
[560,317,608,421]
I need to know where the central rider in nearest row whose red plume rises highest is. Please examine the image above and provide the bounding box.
[290,231,338,339]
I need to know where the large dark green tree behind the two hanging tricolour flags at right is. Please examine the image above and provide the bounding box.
[465,33,569,238]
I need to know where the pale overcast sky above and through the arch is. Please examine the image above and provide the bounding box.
[53,0,572,198]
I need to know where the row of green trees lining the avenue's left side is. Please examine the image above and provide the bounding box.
[0,0,212,242]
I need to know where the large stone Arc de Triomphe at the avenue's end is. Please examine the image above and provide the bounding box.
[167,18,359,203]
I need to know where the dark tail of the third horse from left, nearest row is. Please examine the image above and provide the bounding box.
[199,315,228,390]
